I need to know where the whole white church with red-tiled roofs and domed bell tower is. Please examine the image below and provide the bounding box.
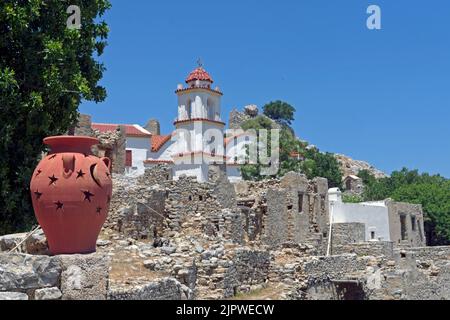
[92,64,255,182]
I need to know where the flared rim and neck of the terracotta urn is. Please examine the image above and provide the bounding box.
[44,136,99,155]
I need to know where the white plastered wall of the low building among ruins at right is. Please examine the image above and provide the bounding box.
[330,202,391,241]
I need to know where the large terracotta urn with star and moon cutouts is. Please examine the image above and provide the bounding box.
[31,136,112,255]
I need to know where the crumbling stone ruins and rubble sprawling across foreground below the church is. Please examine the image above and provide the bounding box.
[0,166,450,300]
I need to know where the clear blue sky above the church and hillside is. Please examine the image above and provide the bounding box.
[80,0,450,177]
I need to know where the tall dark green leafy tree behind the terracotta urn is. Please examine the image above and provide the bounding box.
[0,0,110,233]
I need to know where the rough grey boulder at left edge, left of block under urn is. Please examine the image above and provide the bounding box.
[0,253,61,292]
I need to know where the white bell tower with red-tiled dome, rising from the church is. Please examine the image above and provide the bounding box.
[173,62,225,182]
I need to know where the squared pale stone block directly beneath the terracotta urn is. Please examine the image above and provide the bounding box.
[58,253,110,300]
